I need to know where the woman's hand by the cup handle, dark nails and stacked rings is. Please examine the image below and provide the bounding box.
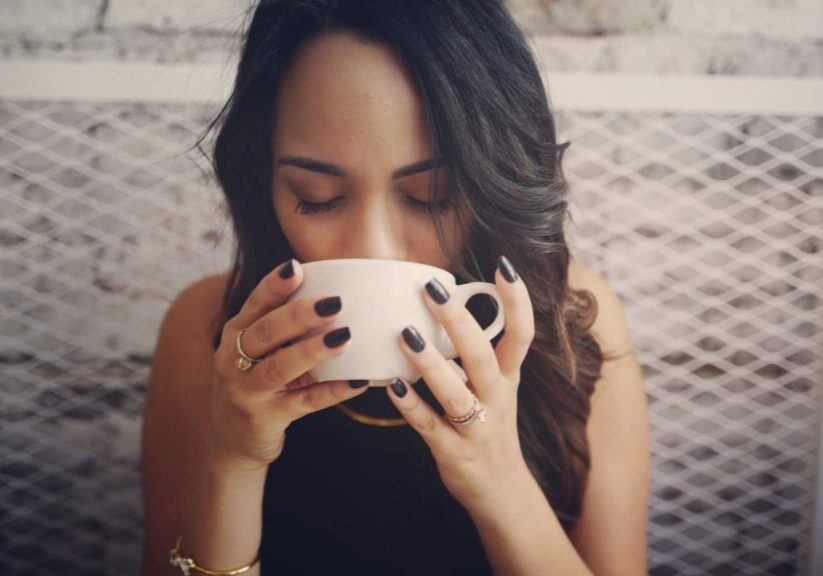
[387,256,534,508]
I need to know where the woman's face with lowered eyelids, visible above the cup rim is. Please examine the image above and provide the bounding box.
[272,34,460,268]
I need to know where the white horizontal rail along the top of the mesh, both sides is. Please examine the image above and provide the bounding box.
[0,60,823,116]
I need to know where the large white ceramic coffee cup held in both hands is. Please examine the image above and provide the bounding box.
[289,258,506,386]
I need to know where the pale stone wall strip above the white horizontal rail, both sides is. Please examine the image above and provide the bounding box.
[0,0,823,76]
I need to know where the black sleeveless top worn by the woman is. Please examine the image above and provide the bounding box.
[260,380,492,576]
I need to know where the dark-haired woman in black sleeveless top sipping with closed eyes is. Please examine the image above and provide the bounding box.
[143,0,648,576]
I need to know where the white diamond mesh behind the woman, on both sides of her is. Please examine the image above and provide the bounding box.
[0,97,823,575]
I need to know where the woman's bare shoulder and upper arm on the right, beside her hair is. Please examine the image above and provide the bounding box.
[569,262,651,576]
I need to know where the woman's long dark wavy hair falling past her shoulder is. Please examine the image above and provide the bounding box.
[197,0,603,533]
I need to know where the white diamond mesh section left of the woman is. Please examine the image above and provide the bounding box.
[0,102,229,575]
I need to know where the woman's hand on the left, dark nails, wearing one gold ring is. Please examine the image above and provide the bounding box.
[210,260,368,471]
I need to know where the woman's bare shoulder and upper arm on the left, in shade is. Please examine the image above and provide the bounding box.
[141,274,227,574]
